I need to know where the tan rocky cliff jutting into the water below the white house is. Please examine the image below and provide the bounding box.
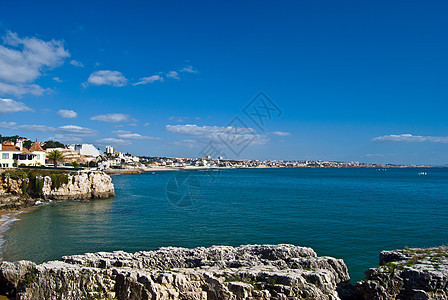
[0,171,115,210]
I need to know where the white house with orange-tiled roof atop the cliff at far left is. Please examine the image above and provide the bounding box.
[0,141,45,168]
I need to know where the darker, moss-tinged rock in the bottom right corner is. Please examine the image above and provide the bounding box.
[355,246,448,299]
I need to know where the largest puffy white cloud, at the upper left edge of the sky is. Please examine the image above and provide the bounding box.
[0,31,70,95]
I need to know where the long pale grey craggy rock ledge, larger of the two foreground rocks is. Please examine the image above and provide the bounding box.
[0,245,349,299]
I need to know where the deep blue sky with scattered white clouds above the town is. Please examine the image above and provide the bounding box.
[0,0,448,164]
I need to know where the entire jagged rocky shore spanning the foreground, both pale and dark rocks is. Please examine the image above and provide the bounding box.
[0,244,448,299]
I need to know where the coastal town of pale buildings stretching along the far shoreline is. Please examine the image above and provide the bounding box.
[0,136,429,173]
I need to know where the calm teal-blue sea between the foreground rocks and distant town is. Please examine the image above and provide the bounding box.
[1,168,448,280]
